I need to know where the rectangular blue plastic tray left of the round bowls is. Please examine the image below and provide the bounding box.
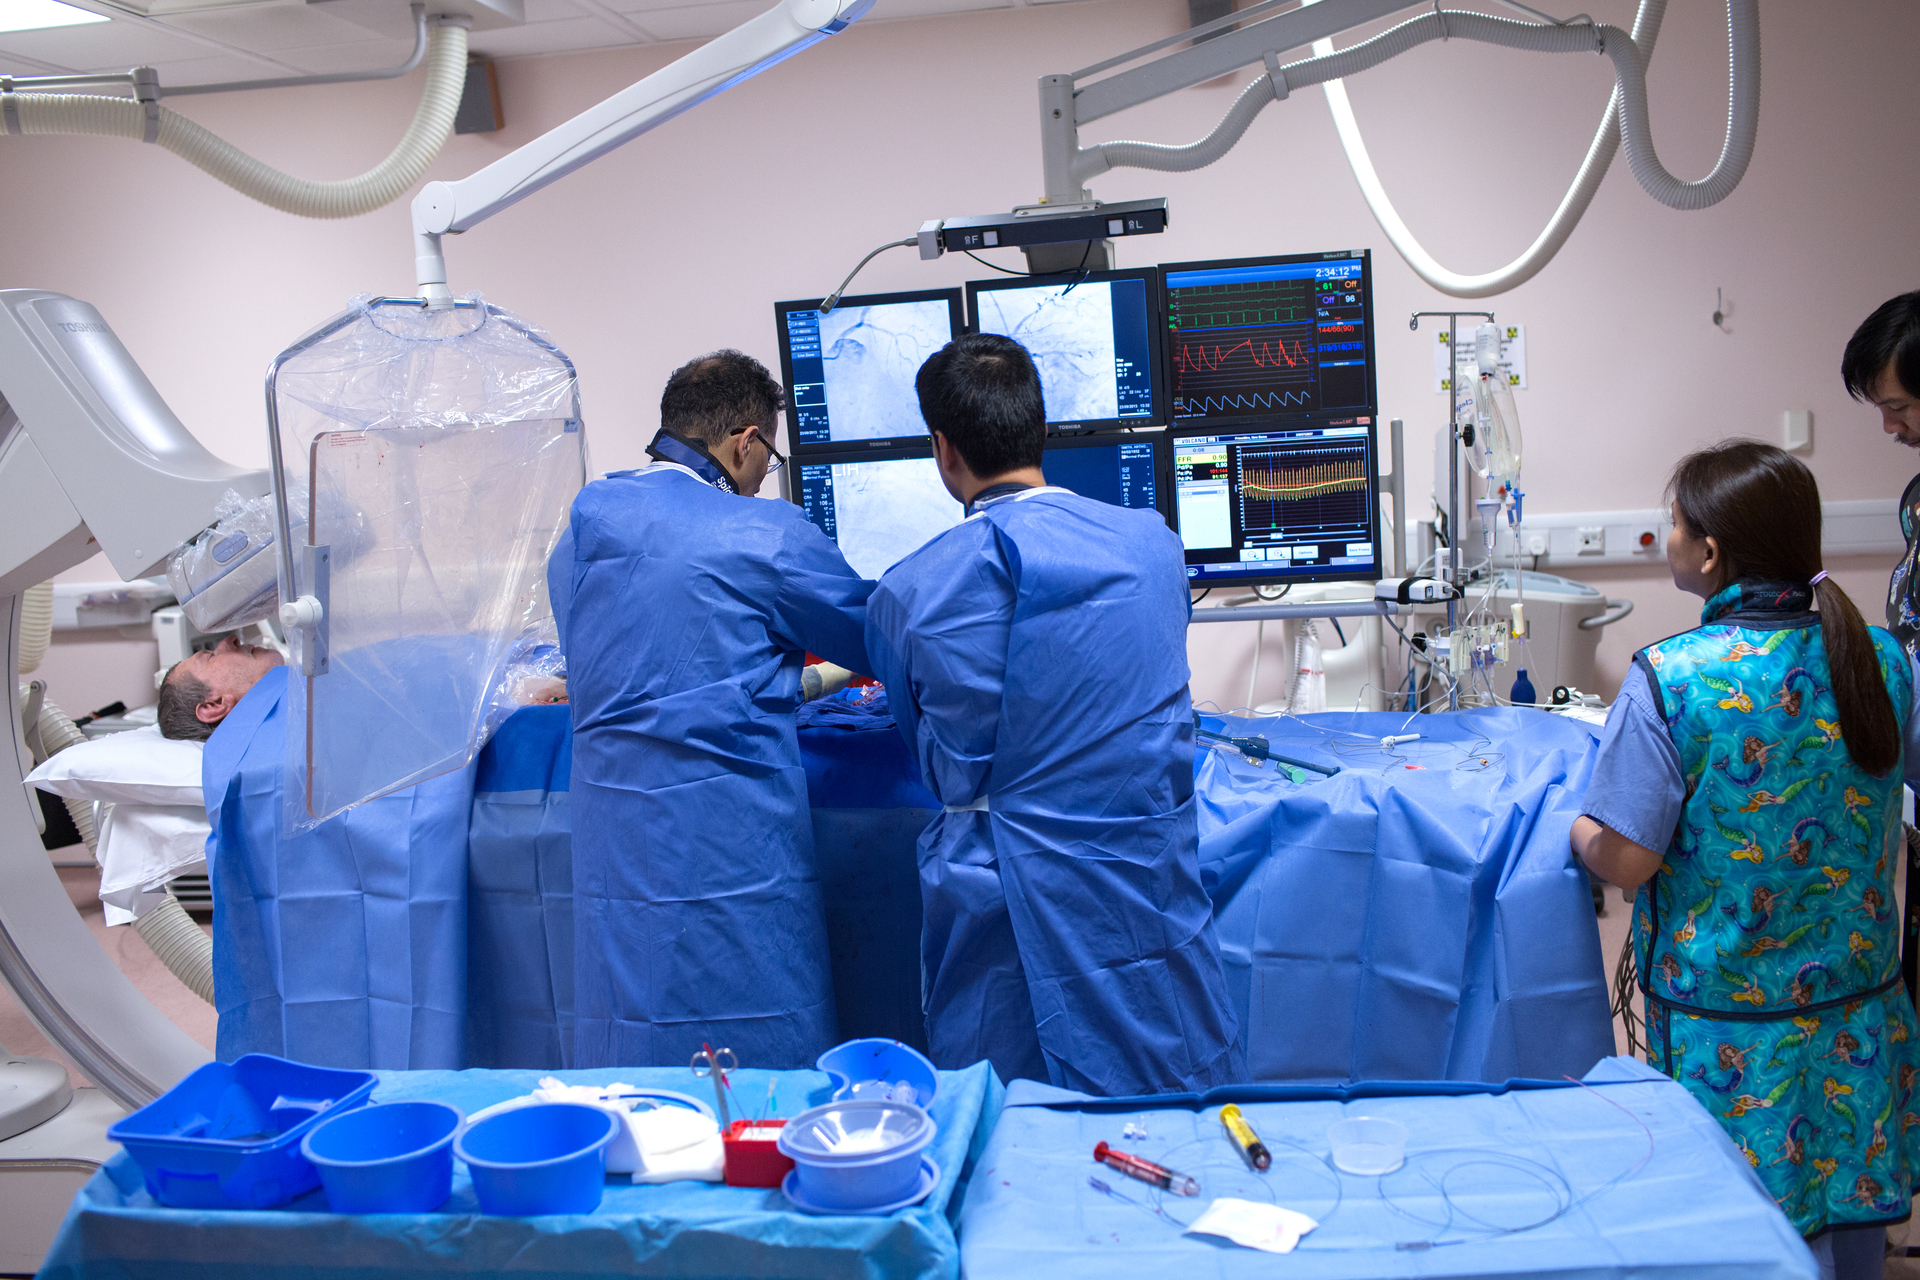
[108,1054,374,1209]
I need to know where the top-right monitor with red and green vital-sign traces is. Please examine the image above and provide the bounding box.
[1160,249,1379,430]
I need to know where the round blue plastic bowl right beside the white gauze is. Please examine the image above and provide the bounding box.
[453,1102,622,1217]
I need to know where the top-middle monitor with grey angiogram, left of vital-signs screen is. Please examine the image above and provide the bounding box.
[966,269,1167,432]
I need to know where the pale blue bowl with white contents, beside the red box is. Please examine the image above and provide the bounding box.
[780,1100,935,1213]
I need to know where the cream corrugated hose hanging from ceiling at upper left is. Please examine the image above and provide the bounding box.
[13,25,467,217]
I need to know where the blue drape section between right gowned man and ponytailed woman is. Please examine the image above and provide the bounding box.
[1194,708,1613,1080]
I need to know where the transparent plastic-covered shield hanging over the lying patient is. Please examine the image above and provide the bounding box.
[273,297,588,833]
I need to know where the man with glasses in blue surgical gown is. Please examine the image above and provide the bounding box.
[547,351,874,1067]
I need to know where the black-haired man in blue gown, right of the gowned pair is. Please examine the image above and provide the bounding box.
[866,334,1244,1096]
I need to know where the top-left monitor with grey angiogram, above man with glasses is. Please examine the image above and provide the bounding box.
[774,290,966,453]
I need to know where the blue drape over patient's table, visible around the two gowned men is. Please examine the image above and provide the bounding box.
[207,676,1613,1080]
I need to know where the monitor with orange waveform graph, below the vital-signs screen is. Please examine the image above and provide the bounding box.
[1171,415,1380,587]
